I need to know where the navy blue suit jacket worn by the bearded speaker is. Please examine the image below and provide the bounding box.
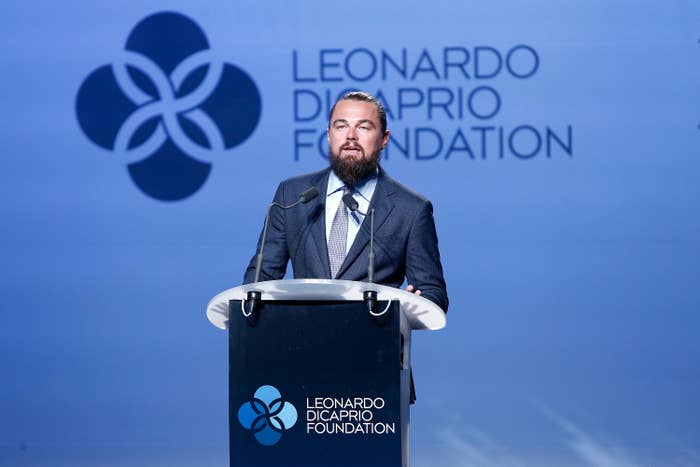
[244,168,448,311]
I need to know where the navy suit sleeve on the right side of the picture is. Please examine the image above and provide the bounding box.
[406,201,449,312]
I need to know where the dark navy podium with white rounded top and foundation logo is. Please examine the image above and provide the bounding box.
[207,279,445,467]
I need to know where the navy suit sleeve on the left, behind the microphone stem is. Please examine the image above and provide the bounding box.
[243,182,289,284]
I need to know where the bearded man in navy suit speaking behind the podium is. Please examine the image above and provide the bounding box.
[244,92,448,311]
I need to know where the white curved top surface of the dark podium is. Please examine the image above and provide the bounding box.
[207,279,446,330]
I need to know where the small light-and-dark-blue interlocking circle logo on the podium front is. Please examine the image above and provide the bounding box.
[238,386,297,446]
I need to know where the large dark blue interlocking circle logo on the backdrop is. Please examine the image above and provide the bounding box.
[76,12,261,201]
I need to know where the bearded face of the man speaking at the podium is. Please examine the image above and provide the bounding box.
[328,99,389,186]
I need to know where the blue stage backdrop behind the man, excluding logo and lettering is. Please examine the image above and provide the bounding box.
[0,0,700,466]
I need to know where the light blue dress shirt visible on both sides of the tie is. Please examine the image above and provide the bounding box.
[326,170,378,254]
